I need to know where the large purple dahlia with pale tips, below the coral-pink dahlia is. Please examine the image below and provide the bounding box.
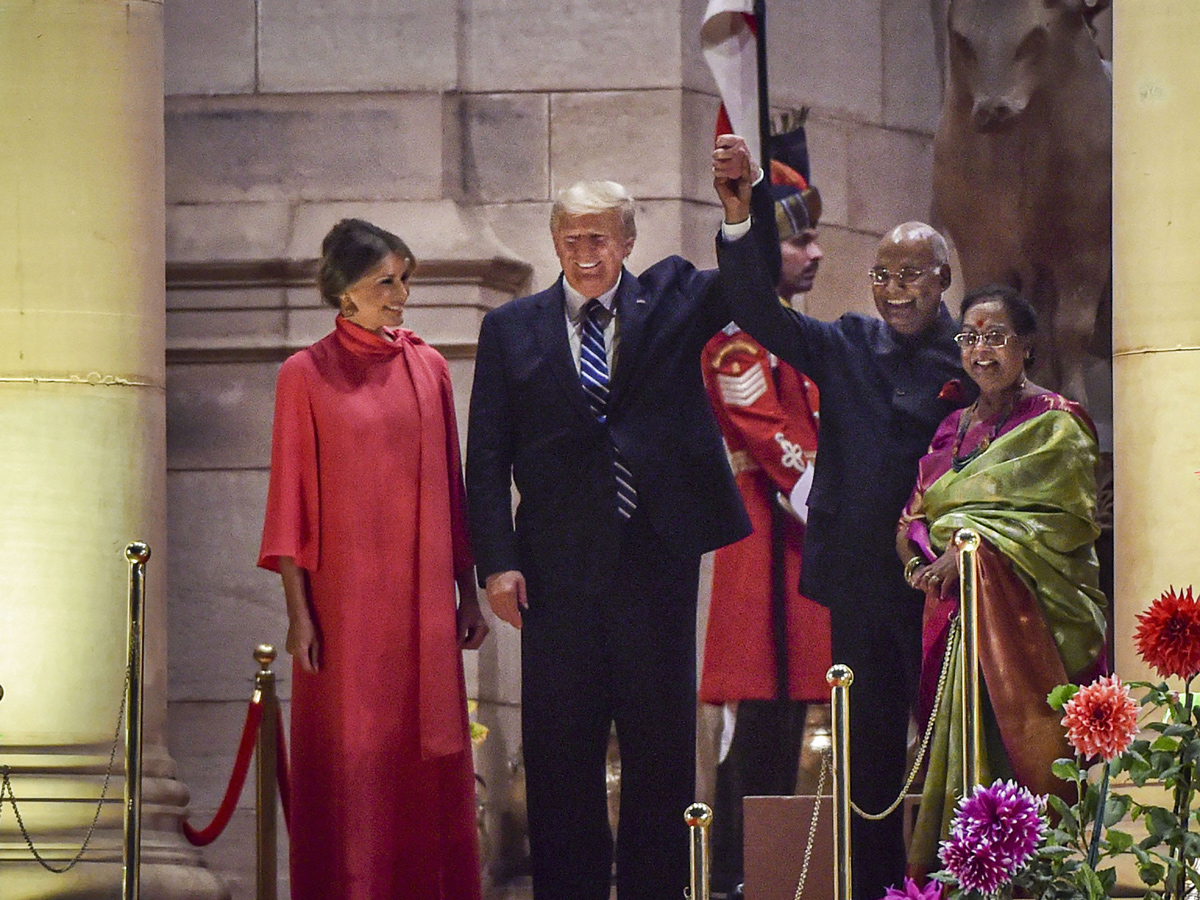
[938,779,1046,894]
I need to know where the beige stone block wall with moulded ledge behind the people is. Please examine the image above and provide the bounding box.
[159,0,979,900]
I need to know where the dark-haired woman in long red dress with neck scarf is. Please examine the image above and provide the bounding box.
[258,218,487,900]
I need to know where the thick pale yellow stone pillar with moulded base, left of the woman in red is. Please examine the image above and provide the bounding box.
[0,0,223,900]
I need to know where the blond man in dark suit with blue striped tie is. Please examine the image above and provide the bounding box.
[467,136,772,900]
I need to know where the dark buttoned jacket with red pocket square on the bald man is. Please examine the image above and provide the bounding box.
[718,234,977,610]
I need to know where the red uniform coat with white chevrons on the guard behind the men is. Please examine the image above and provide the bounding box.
[700,328,830,703]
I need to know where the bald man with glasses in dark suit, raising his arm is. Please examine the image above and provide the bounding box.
[718,213,973,898]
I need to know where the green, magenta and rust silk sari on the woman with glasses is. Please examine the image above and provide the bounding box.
[906,394,1106,876]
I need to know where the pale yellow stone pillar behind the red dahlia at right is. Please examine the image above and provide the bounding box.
[1112,0,1200,679]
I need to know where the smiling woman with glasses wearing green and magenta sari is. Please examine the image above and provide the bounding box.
[896,286,1105,877]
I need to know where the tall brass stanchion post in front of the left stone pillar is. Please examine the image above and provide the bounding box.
[121,541,150,900]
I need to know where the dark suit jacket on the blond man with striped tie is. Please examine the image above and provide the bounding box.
[467,257,750,602]
